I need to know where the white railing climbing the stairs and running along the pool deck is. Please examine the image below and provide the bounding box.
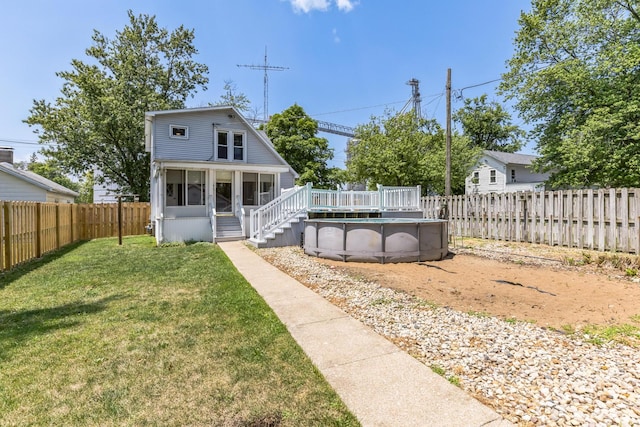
[249,184,421,242]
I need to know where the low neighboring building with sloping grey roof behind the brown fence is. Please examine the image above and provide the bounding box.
[0,162,78,203]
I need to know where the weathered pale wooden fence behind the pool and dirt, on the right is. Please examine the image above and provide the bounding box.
[422,188,640,254]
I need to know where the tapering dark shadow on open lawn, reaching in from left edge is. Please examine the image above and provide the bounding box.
[0,295,125,360]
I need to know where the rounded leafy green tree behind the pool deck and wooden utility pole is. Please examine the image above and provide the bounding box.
[347,111,480,194]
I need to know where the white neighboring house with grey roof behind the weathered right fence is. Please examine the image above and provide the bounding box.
[465,150,549,194]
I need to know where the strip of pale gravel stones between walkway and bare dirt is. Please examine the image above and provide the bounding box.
[258,247,640,426]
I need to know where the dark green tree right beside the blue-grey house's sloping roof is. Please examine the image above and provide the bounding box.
[265,104,342,188]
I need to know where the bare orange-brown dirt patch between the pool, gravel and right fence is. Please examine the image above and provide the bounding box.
[308,240,640,329]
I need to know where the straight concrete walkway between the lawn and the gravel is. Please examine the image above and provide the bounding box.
[219,242,512,427]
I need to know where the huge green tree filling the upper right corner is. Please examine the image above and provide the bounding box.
[501,0,640,187]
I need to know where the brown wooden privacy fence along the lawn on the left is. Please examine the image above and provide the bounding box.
[0,201,150,271]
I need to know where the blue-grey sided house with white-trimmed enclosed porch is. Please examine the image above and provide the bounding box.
[145,106,298,243]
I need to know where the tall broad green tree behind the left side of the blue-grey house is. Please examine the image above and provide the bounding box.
[25,11,208,200]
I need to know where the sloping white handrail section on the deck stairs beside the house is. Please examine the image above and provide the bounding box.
[249,184,311,242]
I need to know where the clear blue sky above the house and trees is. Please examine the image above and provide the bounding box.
[0,0,532,166]
